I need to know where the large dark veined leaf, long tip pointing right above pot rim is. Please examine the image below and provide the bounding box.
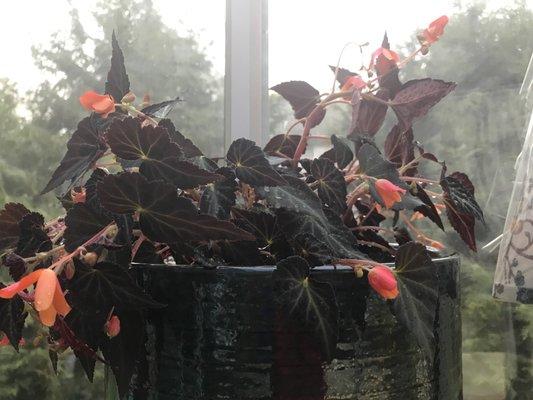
[98,172,253,243]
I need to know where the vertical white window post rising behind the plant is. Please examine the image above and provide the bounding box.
[224,0,268,149]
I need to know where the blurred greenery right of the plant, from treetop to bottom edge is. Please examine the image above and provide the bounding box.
[404,1,533,399]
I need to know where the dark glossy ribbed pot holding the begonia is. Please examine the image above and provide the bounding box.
[131,257,462,400]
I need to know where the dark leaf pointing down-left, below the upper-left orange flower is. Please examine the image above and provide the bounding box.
[41,117,107,194]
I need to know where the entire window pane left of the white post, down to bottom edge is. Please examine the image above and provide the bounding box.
[0,0,225,400]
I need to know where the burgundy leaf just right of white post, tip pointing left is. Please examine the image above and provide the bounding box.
[270,81,326,122]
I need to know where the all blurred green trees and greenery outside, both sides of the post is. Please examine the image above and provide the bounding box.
[0,0,533,400]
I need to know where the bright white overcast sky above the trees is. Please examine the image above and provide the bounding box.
[0,0,533,93]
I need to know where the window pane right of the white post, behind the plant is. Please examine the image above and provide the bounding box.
[269,0,533,400]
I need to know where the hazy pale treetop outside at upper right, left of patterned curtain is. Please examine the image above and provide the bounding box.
[404,1,533,234]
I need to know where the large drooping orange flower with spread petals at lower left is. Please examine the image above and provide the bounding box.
[0,268,70,326]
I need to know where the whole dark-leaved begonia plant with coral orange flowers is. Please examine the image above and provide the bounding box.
[0,16,483,396]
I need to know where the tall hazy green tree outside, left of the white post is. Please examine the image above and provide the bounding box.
[29,0,224,156]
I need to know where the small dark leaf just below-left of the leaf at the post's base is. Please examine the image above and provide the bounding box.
[199,167,237,219]
